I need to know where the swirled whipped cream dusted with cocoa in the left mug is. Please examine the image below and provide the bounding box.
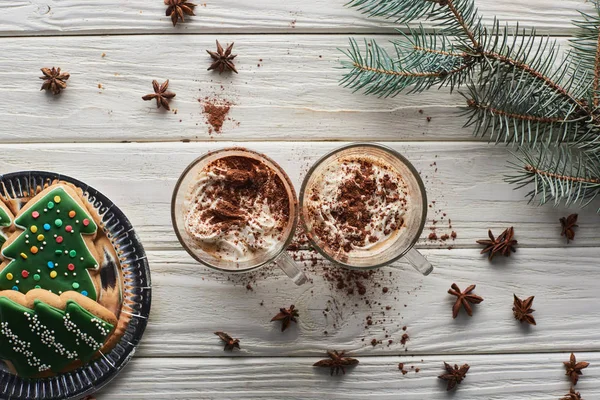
[184,157,289,263]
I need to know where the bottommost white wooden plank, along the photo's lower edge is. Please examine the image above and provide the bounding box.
[98,353,600,400]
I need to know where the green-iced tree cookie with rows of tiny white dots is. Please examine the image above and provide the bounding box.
[0,289,117,378]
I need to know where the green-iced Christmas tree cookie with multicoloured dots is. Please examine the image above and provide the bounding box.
[0,183,100,301]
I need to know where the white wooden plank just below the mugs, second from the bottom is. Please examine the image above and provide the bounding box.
[137,248,600,357]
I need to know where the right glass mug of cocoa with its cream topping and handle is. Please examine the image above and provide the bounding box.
[300,143,433,275]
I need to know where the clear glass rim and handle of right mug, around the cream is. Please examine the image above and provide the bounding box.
[300,143,433,275]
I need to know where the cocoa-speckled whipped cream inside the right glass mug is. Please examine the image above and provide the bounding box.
[305,157,408,256]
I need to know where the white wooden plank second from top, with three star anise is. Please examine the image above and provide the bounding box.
[0,34,567,143]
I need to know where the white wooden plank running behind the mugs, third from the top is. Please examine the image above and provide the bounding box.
[0,142,598,249]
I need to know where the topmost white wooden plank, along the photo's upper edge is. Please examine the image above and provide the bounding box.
[0,0,593,36]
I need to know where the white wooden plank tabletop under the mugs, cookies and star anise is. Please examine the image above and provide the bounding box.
[0,0,600,400]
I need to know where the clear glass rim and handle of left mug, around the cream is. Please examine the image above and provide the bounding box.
[171,148,307,285]
